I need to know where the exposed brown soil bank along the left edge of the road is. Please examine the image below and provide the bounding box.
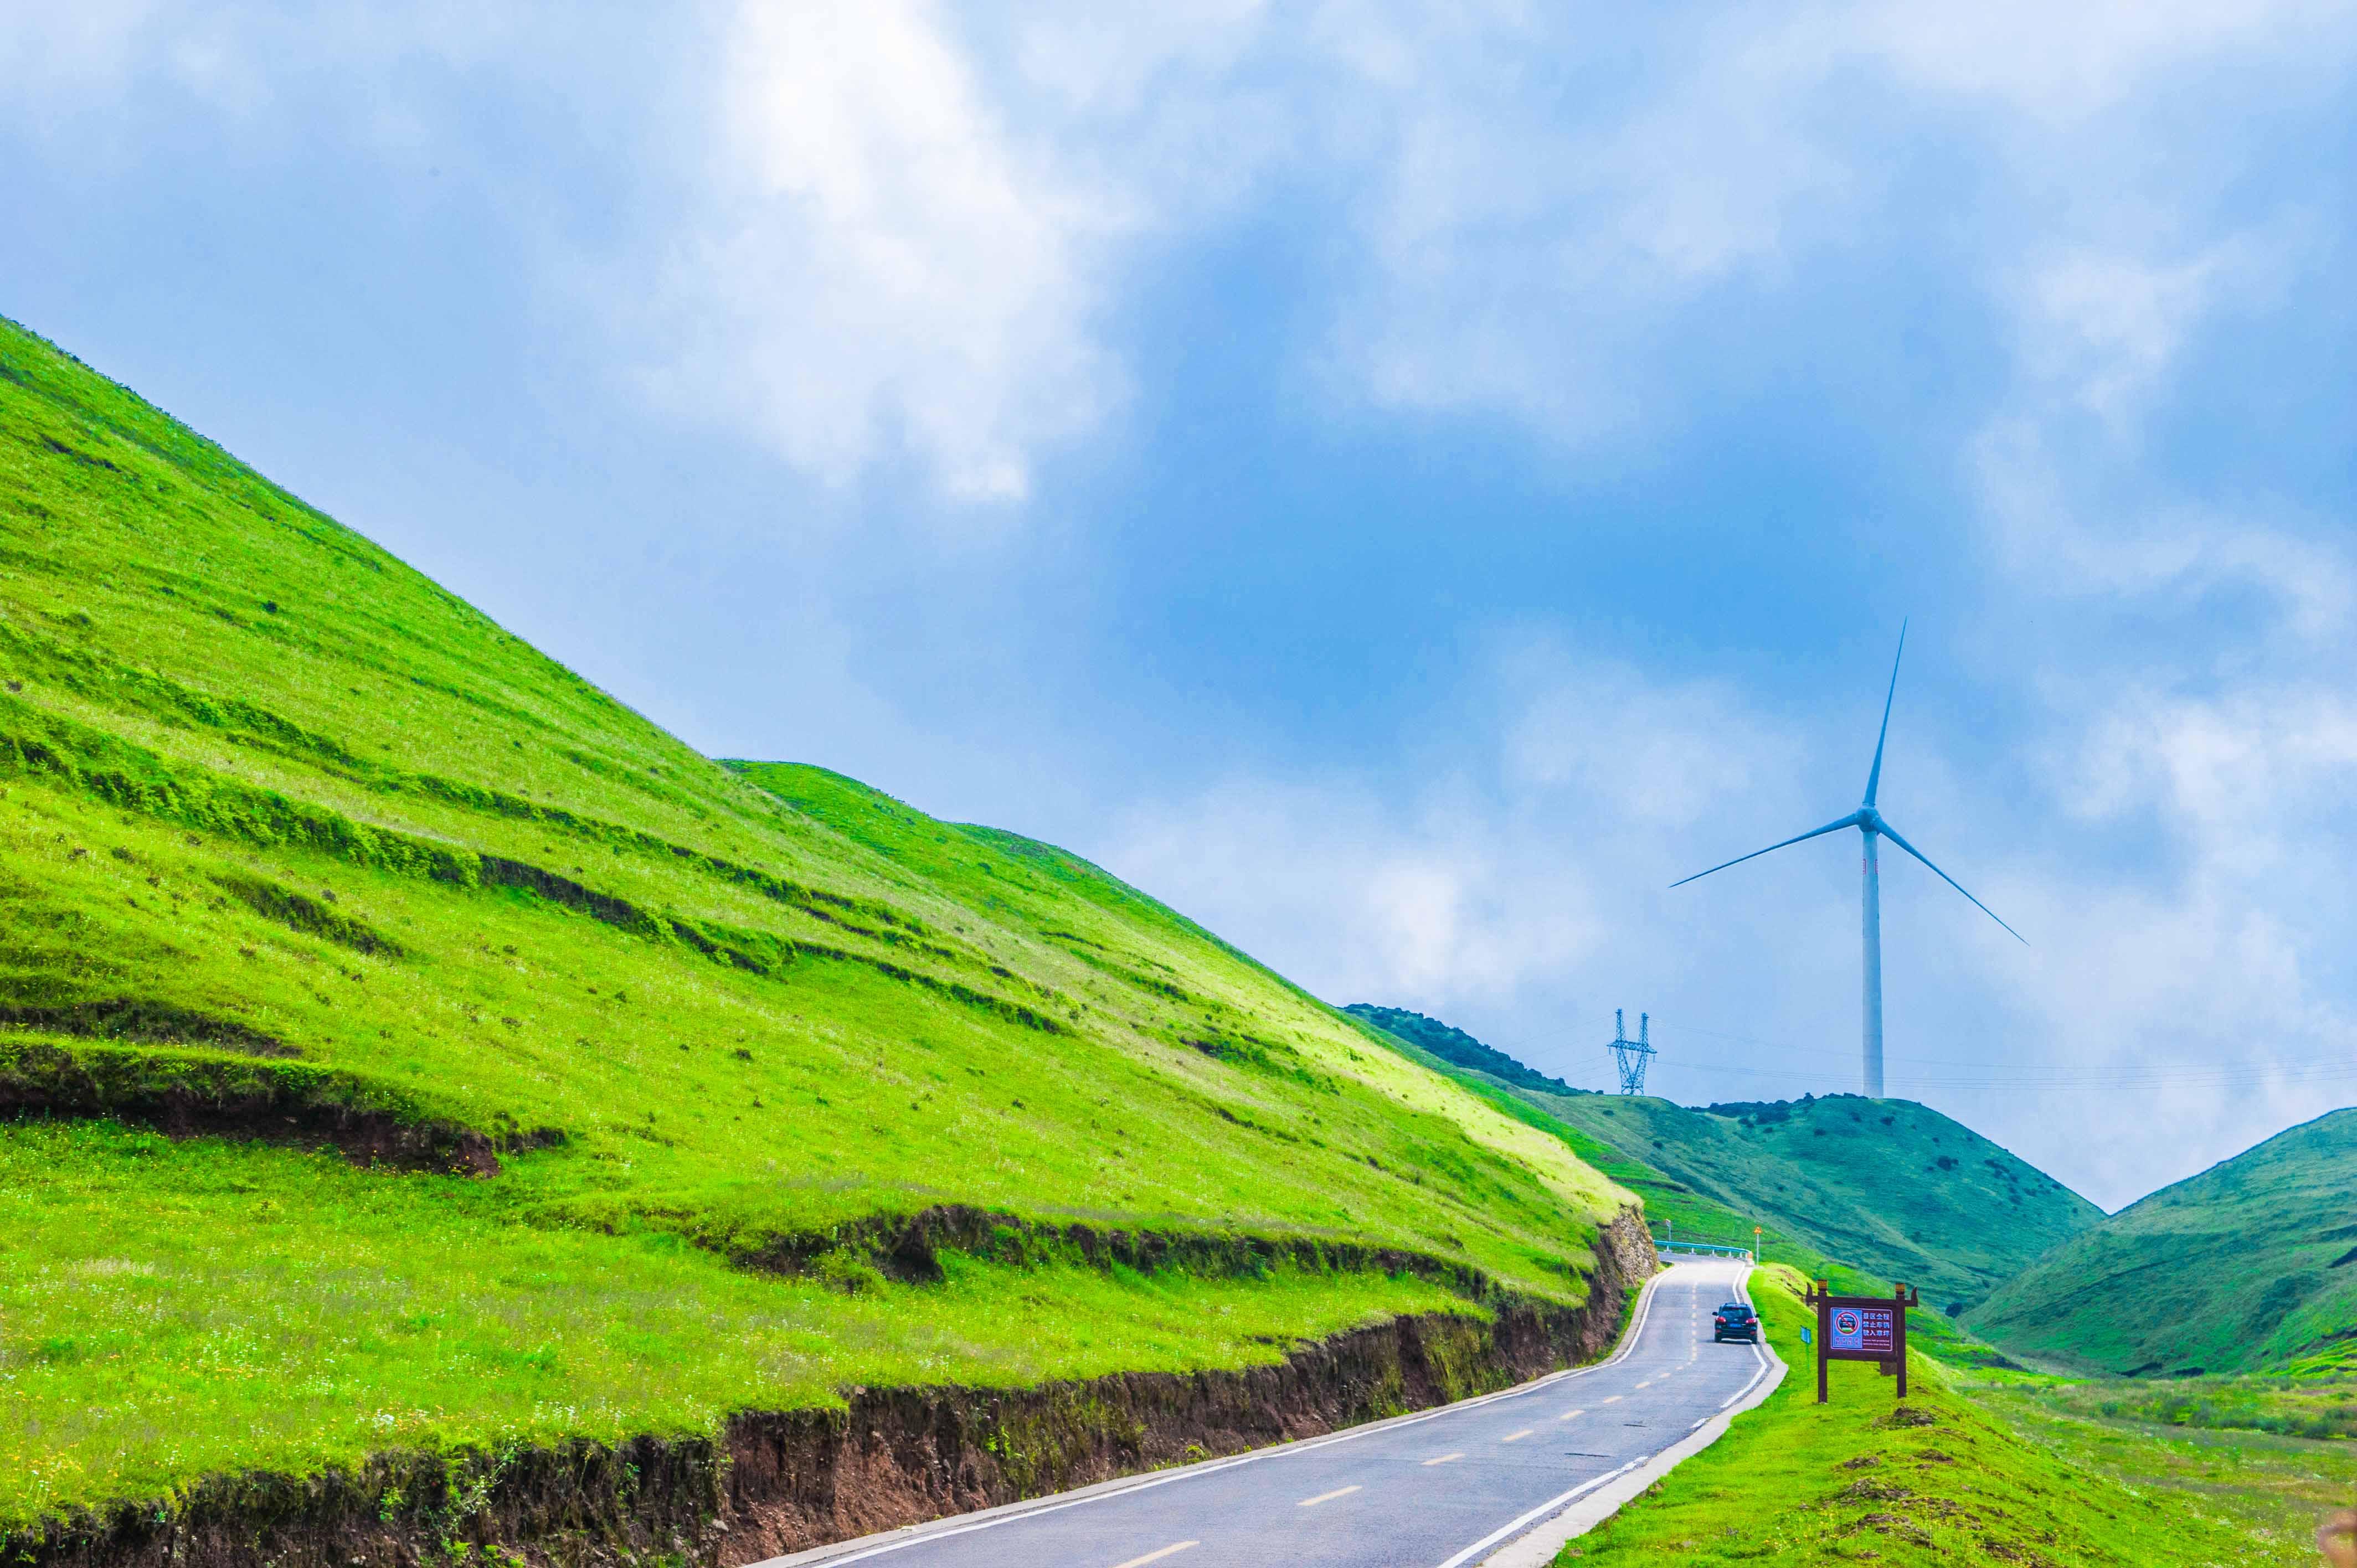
[0,1210,1655,1568]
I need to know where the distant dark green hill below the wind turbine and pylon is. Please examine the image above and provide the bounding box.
[1348,1004,2102,1316]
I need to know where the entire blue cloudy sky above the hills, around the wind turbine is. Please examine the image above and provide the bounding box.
[0,0,2357,1207]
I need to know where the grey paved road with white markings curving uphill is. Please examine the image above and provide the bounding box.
[775,1259,1768,1568]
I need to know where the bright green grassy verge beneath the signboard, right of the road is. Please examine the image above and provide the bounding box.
[1556,1266,2298,1568]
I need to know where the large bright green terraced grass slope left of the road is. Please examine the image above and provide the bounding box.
[0,323,1631,1525]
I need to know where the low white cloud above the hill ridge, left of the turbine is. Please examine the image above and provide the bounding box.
[1108,630,1831,1012]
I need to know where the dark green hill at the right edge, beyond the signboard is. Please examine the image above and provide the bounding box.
[1968,1108,2357,1377]
